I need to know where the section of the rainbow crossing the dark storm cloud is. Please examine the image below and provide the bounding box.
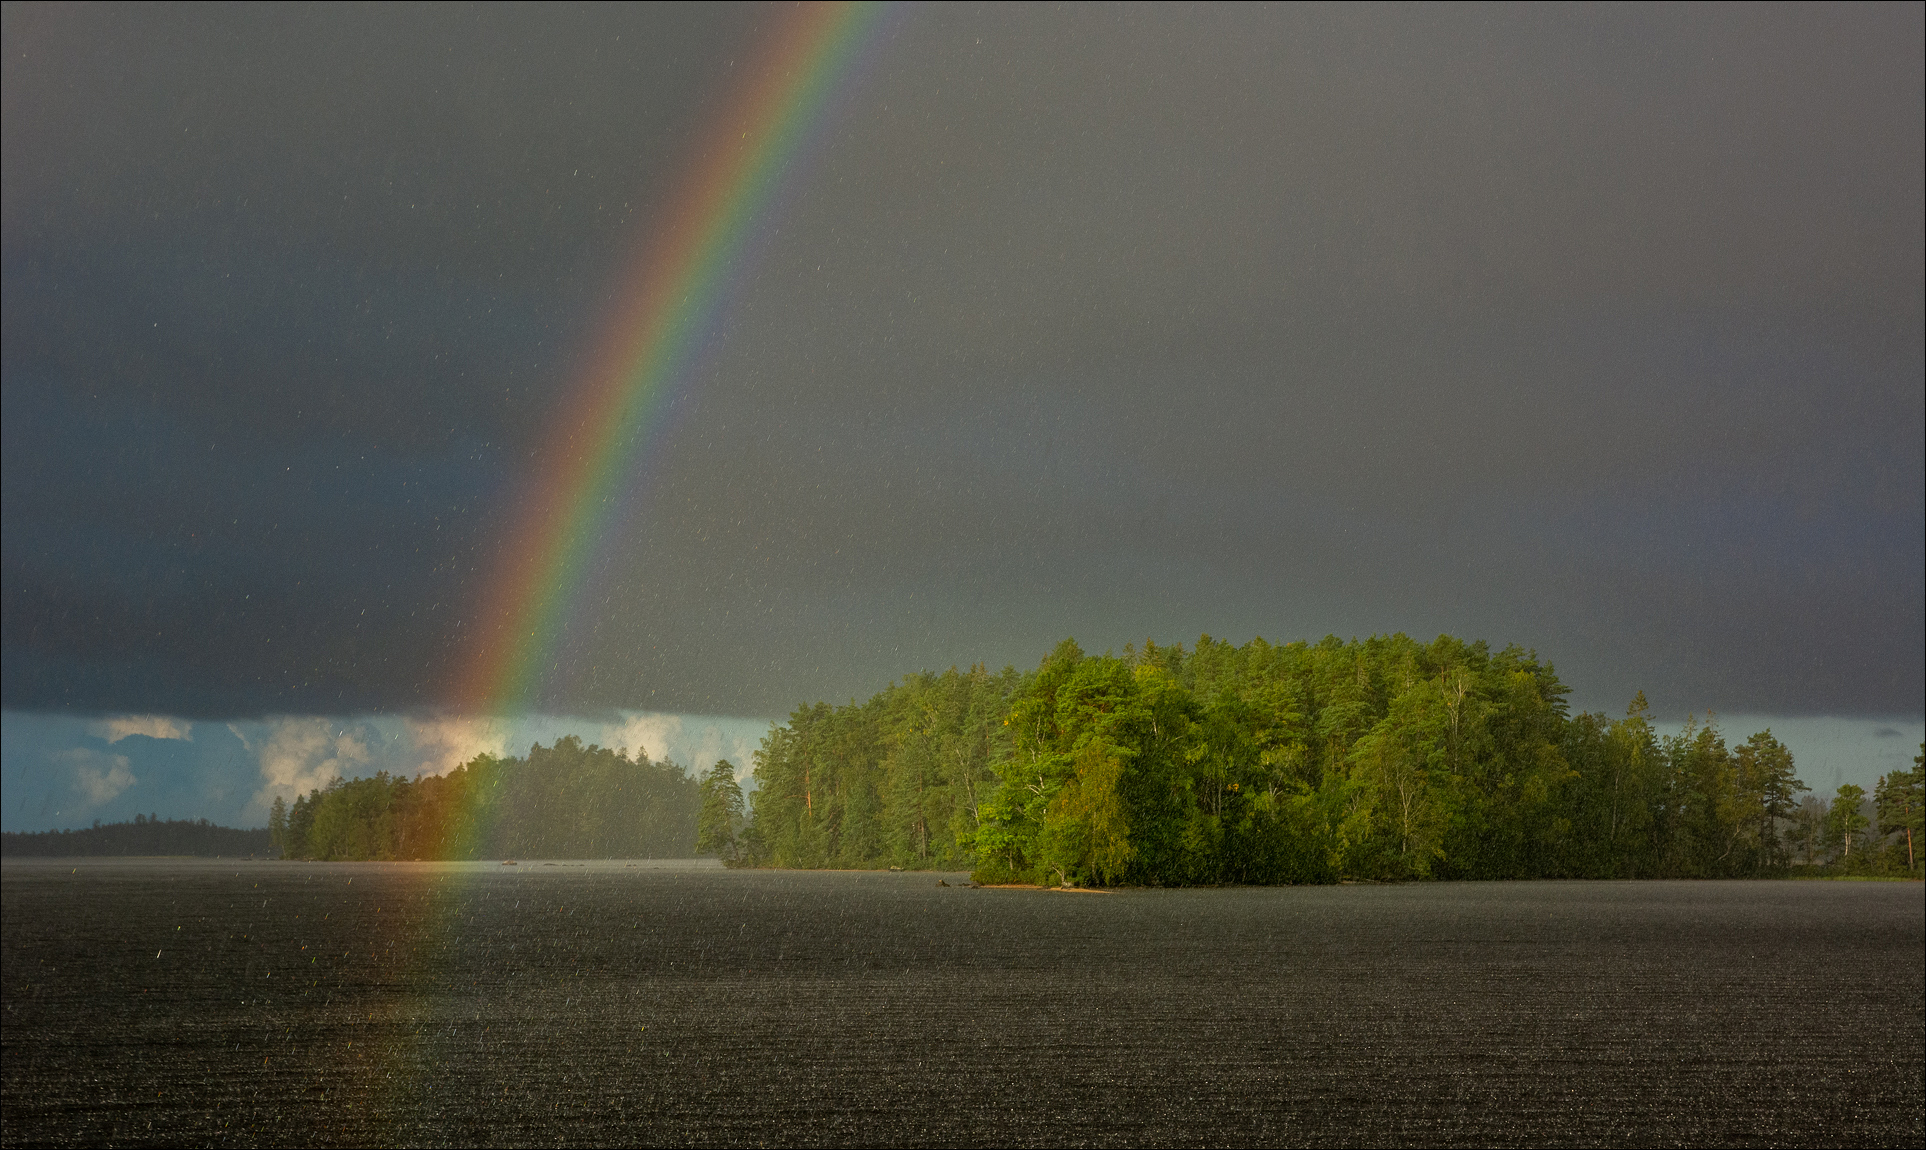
[456,4,888,713]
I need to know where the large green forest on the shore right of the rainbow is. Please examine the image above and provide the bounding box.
[728,634,1922,884]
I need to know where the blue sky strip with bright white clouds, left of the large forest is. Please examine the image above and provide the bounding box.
[0,711,768,830]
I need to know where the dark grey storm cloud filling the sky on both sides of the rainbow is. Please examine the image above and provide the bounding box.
[4,8,1926,715]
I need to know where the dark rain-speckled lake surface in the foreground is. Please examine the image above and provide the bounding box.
[0,859,1926,1146]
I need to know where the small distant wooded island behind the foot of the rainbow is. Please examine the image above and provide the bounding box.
[268,736,701,859]
